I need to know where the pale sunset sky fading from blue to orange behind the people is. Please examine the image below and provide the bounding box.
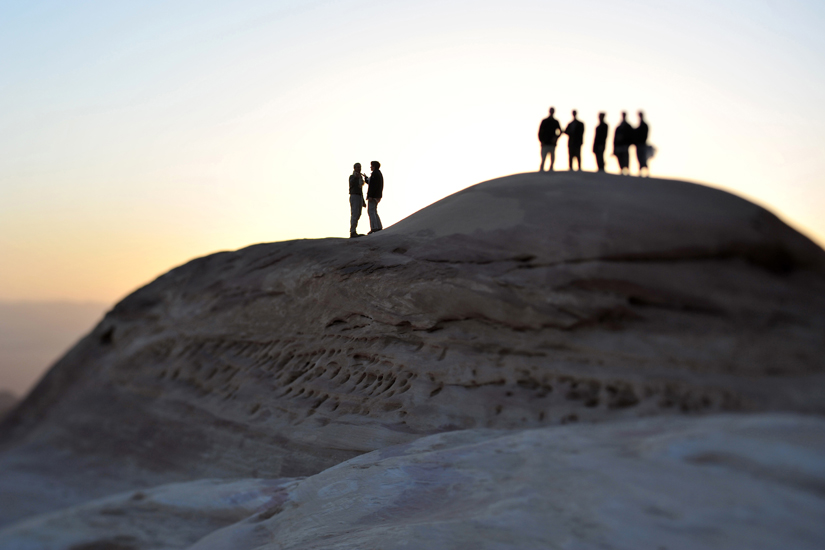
[0,0,825,303]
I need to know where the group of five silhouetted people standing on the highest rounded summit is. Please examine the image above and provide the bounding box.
[539,107,652,176]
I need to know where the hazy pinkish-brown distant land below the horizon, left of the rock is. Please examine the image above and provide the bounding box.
[0,301,108,395]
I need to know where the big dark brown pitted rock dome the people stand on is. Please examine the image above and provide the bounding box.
[0,174,825,522]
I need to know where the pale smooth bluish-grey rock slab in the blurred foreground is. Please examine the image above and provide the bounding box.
[0,415,825,550]
